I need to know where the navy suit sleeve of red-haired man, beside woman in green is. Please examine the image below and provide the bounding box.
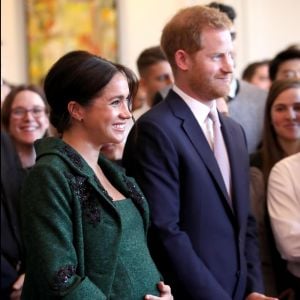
[123,122,231,300]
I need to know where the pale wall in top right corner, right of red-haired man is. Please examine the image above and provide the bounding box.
[243,0,300,67]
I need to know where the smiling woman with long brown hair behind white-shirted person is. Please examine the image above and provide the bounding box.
[251,79,300,295]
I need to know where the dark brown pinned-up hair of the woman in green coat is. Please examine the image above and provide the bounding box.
[44,51,138,133]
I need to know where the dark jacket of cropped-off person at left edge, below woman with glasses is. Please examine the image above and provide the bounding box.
[1,131,24,299]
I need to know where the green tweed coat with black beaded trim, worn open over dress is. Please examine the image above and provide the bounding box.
[21,138,160,300]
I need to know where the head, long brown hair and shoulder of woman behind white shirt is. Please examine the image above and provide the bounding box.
[251,79,300,178]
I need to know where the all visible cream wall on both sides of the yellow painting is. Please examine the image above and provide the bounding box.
[1,0,300,83]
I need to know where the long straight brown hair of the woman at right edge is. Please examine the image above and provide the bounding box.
[262,79,300,182]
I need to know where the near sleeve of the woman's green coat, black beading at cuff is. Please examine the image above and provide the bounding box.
[21,165,106,300]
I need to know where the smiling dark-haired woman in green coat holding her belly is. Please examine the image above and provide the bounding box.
[21,51,172,300]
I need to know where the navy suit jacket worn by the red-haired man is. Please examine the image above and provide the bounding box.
[123,90,262,300]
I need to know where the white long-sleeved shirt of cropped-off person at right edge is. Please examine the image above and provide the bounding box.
[267,153,300,278]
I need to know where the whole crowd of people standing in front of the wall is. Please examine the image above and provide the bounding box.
[1,2,300,300]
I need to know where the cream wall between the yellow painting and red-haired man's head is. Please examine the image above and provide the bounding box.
[118,0,207,75]
